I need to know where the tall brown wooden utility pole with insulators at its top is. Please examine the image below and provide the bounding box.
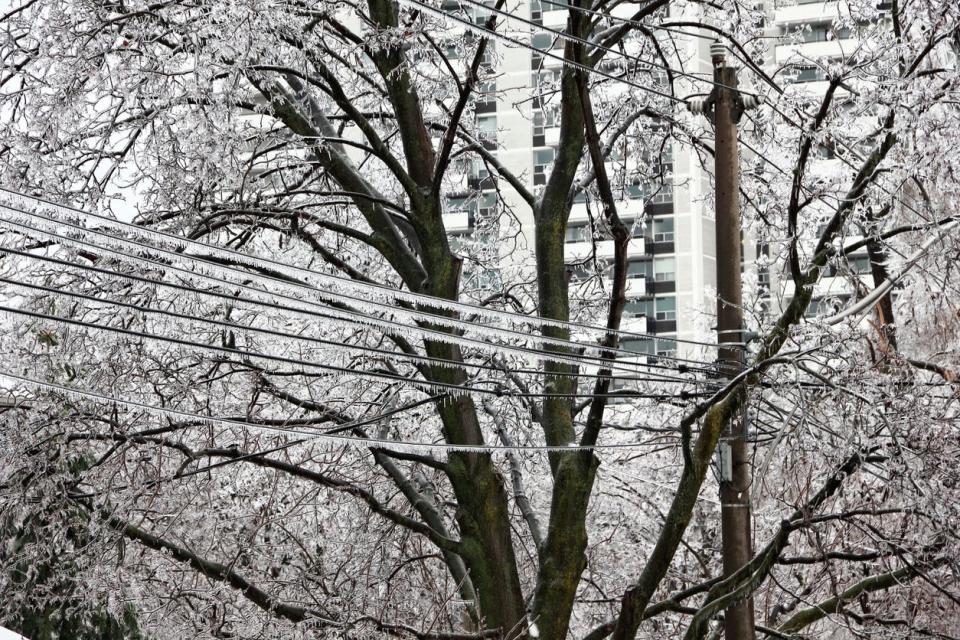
[691,43,758,640]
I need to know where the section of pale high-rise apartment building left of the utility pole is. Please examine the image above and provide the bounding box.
[444,0,715,362]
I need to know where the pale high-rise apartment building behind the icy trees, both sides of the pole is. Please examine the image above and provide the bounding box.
[443,0,884,364]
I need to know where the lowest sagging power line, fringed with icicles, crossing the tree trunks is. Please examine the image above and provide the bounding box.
[0,370,688,453]
